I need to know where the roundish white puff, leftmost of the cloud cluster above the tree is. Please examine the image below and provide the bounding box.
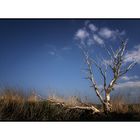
[75,29,89,40]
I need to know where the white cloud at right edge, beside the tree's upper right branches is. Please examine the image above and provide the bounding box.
[125,45,140,64]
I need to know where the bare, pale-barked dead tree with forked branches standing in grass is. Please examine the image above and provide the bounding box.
[80,41,136,113]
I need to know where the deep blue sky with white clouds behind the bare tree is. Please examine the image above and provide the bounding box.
[0,19,140,101]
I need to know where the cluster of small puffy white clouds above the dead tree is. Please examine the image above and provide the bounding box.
[75,20,125,46]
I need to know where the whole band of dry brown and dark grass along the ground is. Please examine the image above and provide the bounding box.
[0,89,140,121]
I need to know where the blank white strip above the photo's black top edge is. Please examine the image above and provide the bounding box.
[0,0,140,18]
